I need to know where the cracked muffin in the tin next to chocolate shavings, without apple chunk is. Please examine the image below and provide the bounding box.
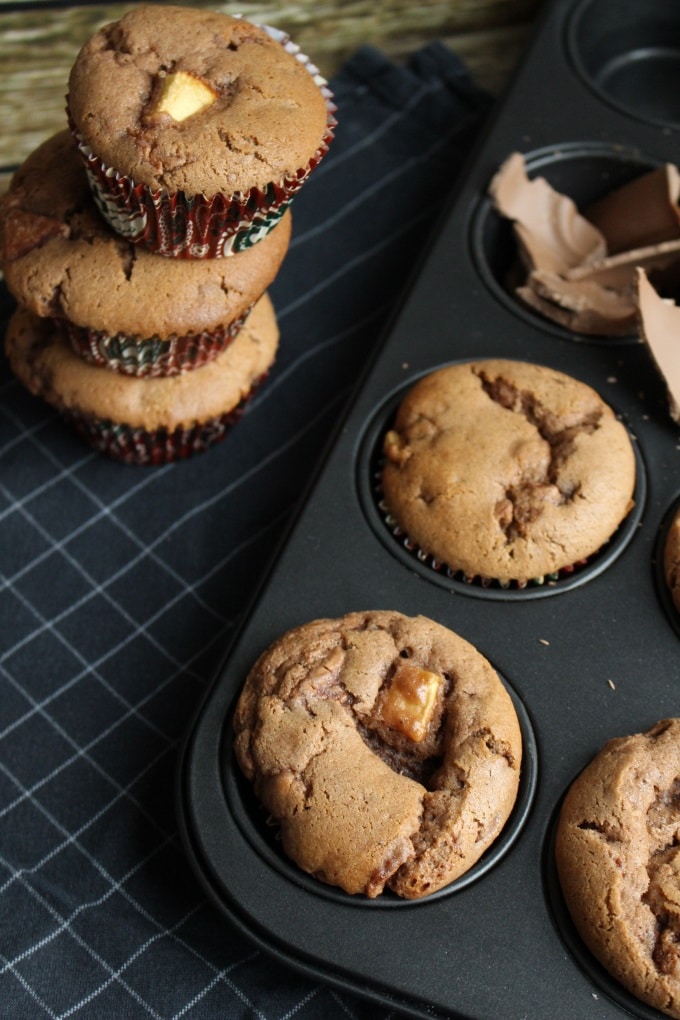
[381,360,635,585]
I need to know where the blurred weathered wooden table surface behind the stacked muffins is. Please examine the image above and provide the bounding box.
[0,0,539,190]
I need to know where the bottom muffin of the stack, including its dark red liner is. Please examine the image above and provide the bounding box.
[5,294,278,464]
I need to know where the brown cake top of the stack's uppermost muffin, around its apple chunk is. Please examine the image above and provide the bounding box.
[68,5,327,196]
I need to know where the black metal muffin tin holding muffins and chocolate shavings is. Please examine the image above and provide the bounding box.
[178,0,680,1020]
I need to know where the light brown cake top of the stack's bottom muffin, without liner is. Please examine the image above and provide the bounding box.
[5,294,278,431]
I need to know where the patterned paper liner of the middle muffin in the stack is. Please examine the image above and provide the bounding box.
[58,309,250,378]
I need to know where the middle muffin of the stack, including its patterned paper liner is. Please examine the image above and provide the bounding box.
[0,131,291,375]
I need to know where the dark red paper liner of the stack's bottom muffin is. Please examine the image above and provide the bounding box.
[61,372,268,465]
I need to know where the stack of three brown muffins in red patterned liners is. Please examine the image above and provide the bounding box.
[0,6,335,464]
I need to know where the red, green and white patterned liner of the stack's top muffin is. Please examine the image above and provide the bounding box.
[68,26,336,258]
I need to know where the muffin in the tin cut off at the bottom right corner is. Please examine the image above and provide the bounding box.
[555,719,680,1018]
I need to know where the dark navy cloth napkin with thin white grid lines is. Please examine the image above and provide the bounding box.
[0,44,489,1020]
